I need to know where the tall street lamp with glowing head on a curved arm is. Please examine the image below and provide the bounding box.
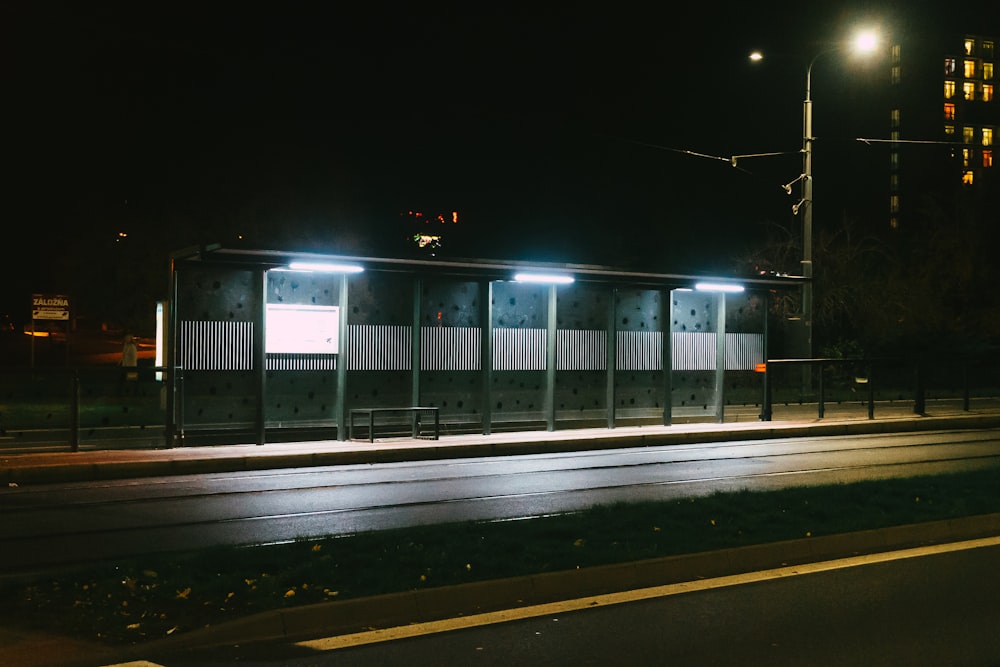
[750,31,879,390]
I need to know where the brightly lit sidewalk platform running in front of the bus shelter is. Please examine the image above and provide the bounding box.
[0,400,1000,485]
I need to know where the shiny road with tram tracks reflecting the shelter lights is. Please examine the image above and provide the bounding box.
[0,430,1000,574]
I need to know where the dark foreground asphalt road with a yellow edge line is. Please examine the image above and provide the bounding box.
[150,538,1000,667]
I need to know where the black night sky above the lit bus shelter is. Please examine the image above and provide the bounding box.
[0,2,992,326]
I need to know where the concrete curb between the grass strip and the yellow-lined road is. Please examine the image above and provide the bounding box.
[137,513,1000,656]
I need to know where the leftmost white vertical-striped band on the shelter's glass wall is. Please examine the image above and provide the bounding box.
[177,320,253,371]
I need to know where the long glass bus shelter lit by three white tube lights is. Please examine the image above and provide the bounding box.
[165,246,794,444]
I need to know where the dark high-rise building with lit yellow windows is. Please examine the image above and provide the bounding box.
[888,33,1000,231]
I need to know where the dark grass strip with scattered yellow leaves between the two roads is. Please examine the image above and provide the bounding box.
[3,469,1000,645]
